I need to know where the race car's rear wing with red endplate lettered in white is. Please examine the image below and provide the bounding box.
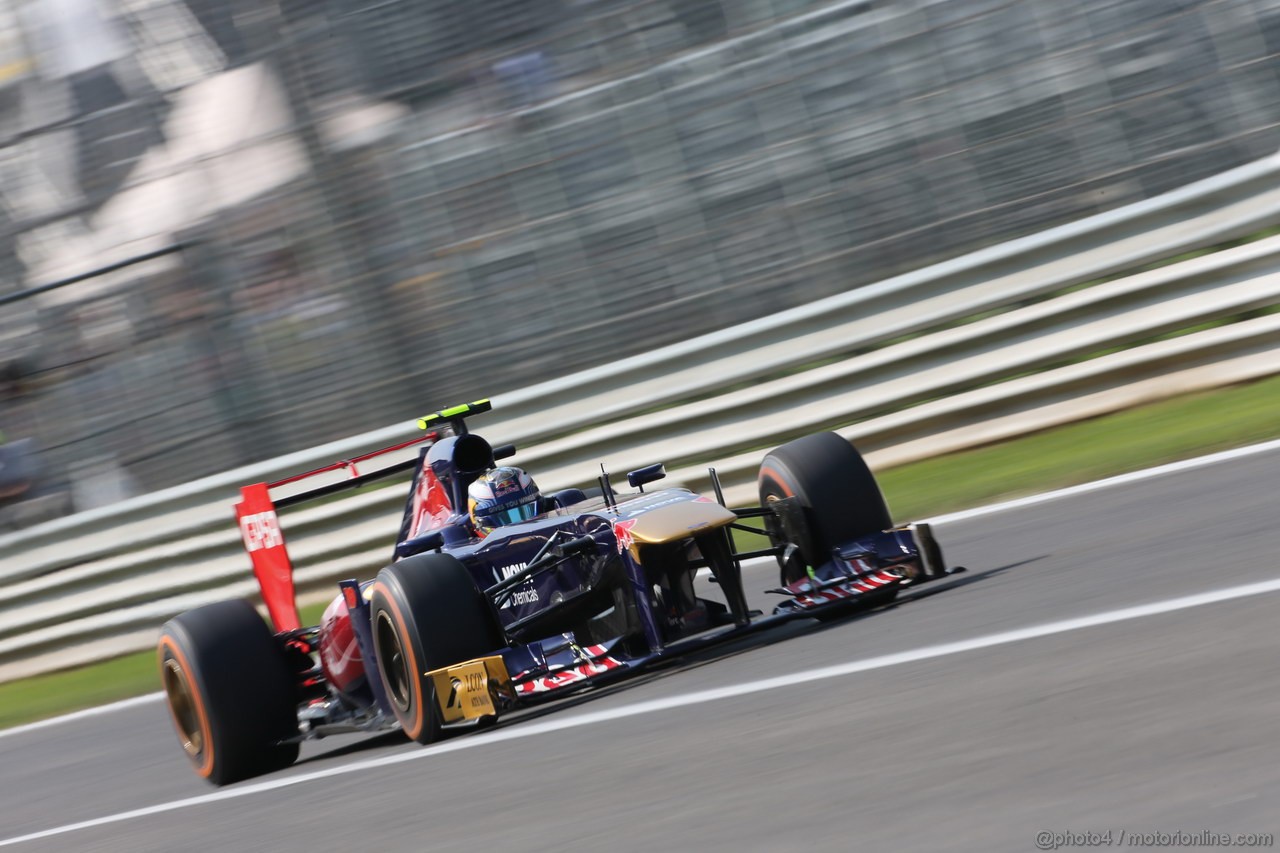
[236,432,440,633]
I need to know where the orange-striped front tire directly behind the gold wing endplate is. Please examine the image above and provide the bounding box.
[370,553,507,744]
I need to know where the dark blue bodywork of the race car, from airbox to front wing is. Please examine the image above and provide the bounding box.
[381,424,952,699]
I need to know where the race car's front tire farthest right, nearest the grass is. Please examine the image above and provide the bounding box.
[758,433,892,584]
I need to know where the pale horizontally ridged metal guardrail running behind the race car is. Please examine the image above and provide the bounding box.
[0,149,1280,680]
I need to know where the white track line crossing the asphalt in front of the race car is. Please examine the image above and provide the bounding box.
[0,578,1280,847]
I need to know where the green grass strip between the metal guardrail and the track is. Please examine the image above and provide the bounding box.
[0,377,1280,727]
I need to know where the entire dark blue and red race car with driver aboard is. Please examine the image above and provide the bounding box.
[159,401,948,785]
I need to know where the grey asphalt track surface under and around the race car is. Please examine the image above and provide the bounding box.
[0,440,1280,852]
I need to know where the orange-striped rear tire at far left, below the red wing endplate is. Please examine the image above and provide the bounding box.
[157,599,298,785]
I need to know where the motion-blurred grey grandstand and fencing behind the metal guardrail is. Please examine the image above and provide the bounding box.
[0,0,1280,523]
